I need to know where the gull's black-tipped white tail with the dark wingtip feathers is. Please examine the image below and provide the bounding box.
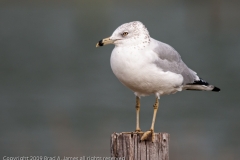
[183,78,220,92]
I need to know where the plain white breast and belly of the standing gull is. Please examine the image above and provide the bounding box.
[110,47,183,96]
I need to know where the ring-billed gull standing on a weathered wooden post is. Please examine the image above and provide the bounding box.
[96,21,220,141]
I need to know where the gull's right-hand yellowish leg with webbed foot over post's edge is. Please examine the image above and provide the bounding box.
[141,98,159,142]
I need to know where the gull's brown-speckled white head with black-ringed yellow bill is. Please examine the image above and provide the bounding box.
[96,21,150,48]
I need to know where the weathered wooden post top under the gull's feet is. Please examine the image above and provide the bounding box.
[111,133,170,160]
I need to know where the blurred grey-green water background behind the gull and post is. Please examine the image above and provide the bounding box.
[0,0,240,160]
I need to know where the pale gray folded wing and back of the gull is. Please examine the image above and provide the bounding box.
[151,39,198,85]
